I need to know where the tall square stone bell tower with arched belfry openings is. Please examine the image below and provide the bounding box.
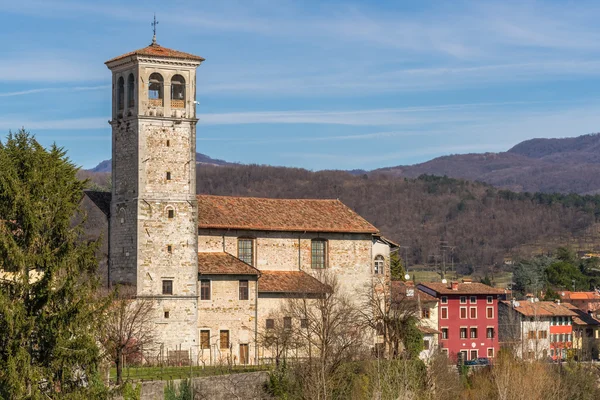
[106,37,204,357]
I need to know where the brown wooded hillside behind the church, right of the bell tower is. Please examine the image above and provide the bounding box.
[197,165,600,269]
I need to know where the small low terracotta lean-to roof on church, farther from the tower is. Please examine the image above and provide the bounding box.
[258,271,331,294]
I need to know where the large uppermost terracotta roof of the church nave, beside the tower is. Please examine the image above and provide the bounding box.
[198,195,378,234]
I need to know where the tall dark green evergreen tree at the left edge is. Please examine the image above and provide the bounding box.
[0,130,103,399]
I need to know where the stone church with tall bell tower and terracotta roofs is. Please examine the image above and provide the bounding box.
[88,39,397,364]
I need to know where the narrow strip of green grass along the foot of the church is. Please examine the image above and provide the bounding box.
[110,365,271,382]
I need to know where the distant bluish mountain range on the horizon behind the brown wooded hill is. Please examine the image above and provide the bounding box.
[90,133,600,194]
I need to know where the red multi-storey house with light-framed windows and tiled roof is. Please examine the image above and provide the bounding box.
[419,279,504,360]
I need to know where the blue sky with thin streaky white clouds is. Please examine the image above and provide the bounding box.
[0,0,600,169]
